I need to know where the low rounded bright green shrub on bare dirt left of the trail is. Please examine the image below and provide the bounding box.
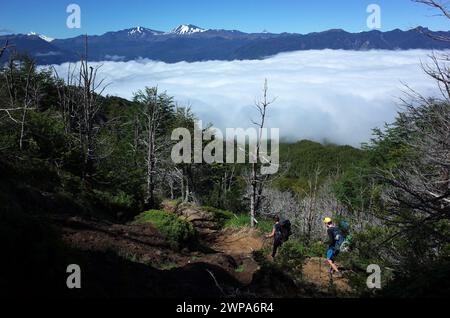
[134,210,197,247]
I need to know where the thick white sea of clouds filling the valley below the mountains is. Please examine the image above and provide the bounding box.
[50,50,438,146]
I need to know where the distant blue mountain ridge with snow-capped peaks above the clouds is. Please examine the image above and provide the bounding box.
[0,24,450,65]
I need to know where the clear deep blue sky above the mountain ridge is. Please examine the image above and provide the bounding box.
[0,0,450,38]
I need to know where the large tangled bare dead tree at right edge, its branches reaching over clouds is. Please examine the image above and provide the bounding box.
[380,54,450,242]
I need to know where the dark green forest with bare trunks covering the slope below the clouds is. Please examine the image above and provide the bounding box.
[0,48,450,297]
